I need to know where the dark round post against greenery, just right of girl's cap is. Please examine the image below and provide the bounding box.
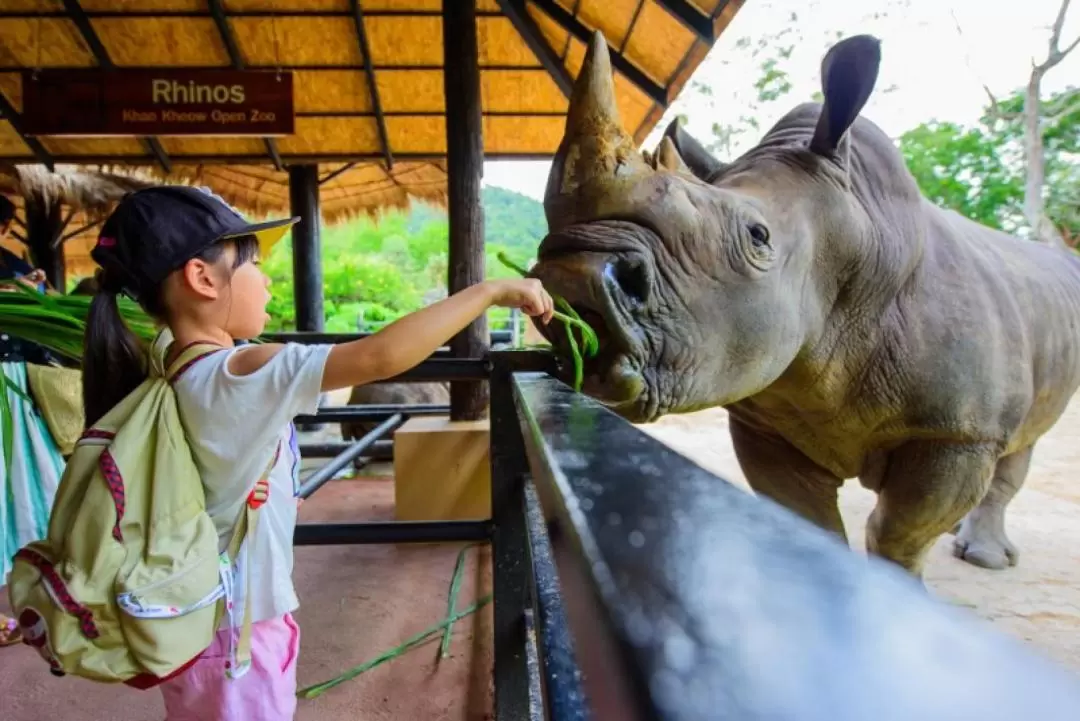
[288,165,325,332]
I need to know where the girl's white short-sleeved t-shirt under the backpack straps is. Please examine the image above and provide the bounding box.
[174,343,332,626]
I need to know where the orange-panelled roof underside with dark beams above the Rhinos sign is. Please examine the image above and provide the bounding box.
[0,0,743,166]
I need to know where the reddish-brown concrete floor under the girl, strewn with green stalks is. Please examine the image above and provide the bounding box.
[0,478,492,721]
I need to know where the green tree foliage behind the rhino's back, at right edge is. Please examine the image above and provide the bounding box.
[900,87,1080,237]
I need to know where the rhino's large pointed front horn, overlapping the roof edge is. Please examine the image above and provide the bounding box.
[544,30,652,230]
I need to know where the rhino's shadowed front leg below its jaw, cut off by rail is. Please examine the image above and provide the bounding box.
[729,418,848,543]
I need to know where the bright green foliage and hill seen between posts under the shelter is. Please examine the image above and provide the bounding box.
[262,187,548,332]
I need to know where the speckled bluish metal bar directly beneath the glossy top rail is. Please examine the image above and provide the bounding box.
[525,480,593,721]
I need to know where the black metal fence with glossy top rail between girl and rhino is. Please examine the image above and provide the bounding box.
[278,334,1080,721]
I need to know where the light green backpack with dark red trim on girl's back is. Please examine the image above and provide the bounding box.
[8,330,280,689]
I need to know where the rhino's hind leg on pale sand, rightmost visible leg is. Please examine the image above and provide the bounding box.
[953,446,1034,570]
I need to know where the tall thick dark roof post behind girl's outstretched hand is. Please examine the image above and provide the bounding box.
[443,0,488,423]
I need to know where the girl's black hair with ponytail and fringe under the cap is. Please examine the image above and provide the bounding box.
[82,235,259,427]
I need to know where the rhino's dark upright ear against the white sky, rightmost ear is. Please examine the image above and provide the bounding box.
[810,35,881,157]
